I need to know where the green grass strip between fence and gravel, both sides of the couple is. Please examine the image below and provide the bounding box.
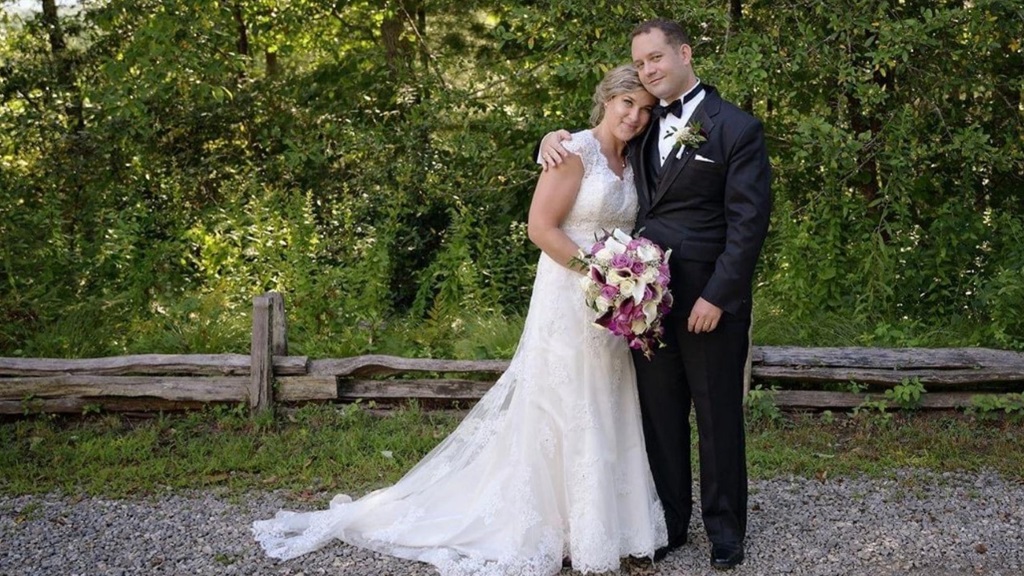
[0,404,1024,498]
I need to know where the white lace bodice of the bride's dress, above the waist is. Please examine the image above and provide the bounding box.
[562,130,637,248]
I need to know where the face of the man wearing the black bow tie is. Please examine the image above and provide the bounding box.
[633,28,694,101]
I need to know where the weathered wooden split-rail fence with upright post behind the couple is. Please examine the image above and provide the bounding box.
[0,292,1024,414]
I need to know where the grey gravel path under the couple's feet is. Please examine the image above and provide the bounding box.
[0,470,1024,576]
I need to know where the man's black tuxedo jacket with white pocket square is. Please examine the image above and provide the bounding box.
[629,84,771,317]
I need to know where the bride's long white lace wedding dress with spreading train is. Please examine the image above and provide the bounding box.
[253,130,667,576]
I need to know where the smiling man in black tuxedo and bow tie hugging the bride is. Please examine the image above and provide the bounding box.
[541,19,771,569]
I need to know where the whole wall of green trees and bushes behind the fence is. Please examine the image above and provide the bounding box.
[0,0,1024,357]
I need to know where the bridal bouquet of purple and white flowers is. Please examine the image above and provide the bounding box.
[579,229,672,358]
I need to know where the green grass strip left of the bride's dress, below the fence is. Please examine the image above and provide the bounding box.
[0,405,456,497]
